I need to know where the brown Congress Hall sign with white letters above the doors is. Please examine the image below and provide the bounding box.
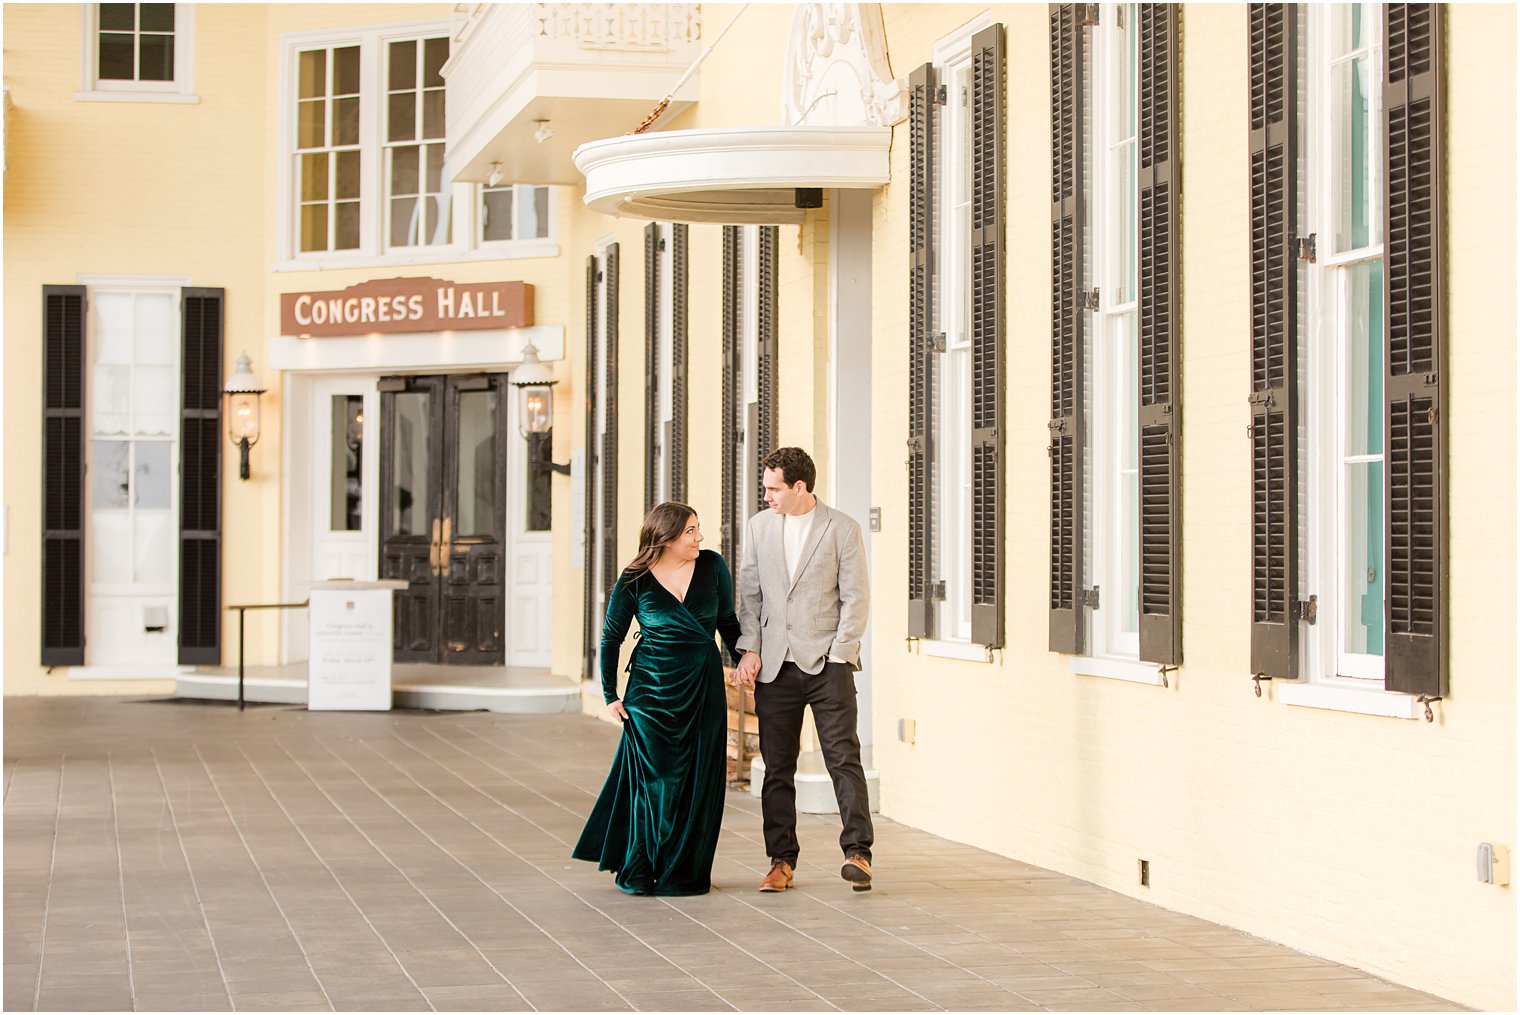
[280,278,534,339]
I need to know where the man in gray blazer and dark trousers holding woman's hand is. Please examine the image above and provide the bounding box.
[734,448,874,892]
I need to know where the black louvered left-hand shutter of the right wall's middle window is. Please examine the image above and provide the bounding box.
[1049,3,1088,653]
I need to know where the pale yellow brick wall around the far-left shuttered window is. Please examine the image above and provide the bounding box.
[5,5,280,694]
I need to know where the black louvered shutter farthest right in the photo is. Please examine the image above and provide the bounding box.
[1383,3,1447,694]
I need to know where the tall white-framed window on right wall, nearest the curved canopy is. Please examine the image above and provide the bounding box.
[926,33,986,659]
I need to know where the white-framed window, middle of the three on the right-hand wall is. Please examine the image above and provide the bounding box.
[1084,3,1140,661]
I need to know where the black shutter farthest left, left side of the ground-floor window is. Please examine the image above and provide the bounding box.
[43,286,85,666]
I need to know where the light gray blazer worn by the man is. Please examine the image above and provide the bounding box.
[739,501,871,682]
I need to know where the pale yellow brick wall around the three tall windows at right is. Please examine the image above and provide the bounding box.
[851,5,1515,1007]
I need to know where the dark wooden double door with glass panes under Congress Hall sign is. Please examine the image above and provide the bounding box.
[380,374,506,666]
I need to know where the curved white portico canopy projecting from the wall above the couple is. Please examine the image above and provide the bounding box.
[575,126,892,225]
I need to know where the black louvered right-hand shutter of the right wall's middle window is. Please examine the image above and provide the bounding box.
[1135,3,1183,666]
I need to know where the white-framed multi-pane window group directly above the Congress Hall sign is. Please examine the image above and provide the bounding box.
[275,21,559,270]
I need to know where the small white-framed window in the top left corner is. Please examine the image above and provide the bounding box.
[74,3,199,102]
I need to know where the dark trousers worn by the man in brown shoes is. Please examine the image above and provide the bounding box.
[755,662,876,866]
